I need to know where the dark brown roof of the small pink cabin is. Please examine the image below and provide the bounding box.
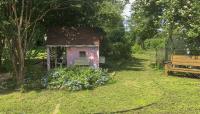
[46,27,103,46]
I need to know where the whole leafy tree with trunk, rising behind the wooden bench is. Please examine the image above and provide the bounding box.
[157,0,200,56]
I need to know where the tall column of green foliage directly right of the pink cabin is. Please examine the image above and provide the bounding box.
[98,2,131,59]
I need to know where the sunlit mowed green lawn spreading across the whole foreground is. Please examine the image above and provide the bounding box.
[0,54,200,114]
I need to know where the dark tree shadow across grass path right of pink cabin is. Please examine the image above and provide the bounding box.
[109,58,148,71]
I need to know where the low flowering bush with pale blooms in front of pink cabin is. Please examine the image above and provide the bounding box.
[43,67,110,91]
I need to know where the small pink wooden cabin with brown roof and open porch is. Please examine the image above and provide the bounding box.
[46,27,103,70]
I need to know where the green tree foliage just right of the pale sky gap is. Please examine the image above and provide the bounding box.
[130,0,162,48]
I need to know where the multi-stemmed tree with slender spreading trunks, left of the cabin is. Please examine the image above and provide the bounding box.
[0,0,67,85]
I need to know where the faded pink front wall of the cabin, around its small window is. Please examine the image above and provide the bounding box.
[67,47,99,68]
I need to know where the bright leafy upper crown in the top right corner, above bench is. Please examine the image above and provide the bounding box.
[157,0,200,38]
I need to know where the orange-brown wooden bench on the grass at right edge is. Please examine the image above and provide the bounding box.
[165,55,200,76]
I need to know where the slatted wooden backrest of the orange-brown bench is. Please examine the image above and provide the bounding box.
[171,55,200,66]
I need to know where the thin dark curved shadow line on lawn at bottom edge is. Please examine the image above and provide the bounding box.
[94,103,156,114]
